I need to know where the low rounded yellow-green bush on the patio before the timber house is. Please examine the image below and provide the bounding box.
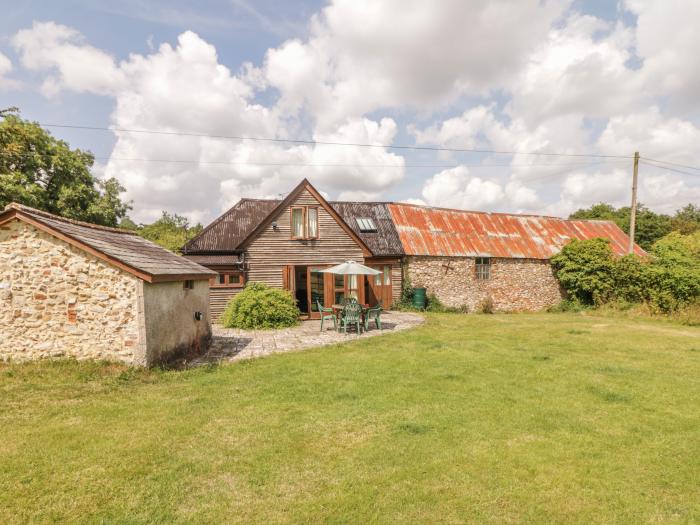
[221,282,299,329]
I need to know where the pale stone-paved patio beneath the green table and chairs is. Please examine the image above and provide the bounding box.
[188,311,424,366]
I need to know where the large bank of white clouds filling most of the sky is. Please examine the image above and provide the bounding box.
[6,0,700,220]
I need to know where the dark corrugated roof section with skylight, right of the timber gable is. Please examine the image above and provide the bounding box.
[329,202,403,257]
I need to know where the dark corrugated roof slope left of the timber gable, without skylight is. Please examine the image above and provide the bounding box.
[182,199,282,254]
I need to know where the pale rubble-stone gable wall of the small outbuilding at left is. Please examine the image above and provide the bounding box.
[0,220,146,364]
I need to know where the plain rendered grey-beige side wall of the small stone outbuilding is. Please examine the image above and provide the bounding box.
[142,280,211,365]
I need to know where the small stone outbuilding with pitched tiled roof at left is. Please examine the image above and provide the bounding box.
[0,204,215,366]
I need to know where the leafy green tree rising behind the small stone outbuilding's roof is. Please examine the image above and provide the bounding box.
[0,108,131,226]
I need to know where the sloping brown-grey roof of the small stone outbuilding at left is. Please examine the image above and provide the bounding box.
[0,203,215,282]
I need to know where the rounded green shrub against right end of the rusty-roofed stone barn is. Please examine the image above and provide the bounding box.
[551,239,615,305]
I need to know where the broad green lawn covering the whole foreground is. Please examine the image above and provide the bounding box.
[0,314,700,524]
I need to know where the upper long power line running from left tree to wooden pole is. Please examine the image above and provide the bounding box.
[40,124,632,159]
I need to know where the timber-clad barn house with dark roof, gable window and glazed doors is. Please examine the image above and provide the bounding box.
[182,179,403,319]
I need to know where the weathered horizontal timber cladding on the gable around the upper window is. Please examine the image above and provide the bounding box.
[246,190,364,288]
